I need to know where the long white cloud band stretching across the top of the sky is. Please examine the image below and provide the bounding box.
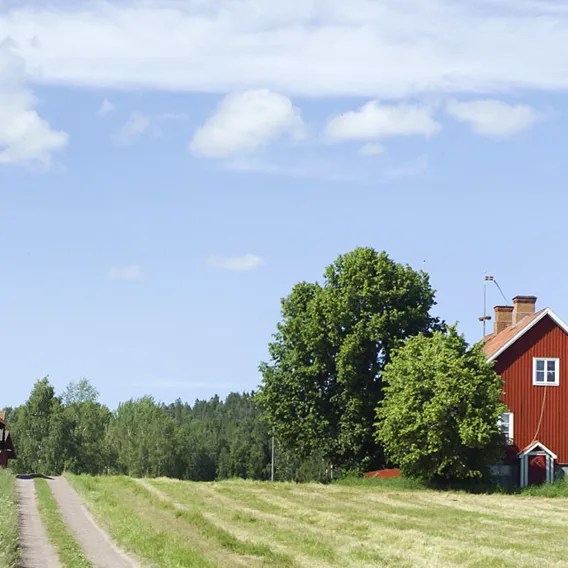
[0,0,568,98]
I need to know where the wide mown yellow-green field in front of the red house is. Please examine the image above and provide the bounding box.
[71,476,568,568]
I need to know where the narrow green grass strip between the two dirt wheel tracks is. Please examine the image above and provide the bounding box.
[35,478,93,568]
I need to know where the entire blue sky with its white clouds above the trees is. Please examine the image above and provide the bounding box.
[0,0,568,406]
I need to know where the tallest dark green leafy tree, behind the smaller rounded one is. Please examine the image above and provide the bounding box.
[258,248,438,468]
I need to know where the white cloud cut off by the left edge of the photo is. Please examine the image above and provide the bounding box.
[0,41,69,168]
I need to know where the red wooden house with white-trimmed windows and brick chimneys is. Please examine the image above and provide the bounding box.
[483,296,568,487]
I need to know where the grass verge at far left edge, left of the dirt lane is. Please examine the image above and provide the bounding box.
[0,469,19,568]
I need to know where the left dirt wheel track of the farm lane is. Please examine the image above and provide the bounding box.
[17,476,61,568]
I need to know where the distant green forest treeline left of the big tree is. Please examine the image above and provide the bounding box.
[6,378,327,481]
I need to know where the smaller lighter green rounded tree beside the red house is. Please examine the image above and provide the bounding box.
[376,327,506,481]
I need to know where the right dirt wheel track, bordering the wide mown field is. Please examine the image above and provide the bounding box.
[48,477,139,568]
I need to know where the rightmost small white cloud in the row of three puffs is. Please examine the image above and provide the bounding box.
[446,99,542,138]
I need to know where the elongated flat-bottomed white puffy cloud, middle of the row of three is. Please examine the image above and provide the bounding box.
[325,101,441,140]
